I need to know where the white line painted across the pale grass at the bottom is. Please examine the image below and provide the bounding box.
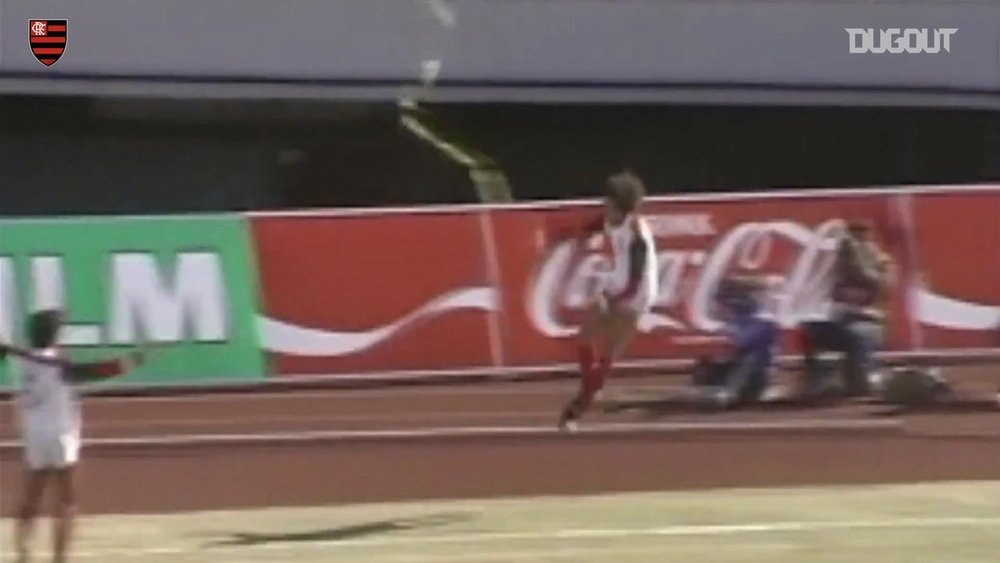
[31,516,1000,561]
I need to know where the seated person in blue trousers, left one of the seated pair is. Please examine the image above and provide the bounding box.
[693,277,780,407]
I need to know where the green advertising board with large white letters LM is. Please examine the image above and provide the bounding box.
[0,215,266,387]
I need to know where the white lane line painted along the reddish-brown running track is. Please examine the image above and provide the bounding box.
[0,419,903,450]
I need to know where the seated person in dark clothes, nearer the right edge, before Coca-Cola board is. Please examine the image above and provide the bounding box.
[801,222,892,397]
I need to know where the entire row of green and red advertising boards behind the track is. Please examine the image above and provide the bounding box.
[0,186,1000,388]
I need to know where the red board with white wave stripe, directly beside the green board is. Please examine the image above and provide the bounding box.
[251,213,497,374]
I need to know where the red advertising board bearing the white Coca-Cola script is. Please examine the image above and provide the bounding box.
[494,196,912,365]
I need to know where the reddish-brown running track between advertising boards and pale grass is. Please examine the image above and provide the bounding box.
[0,372,1000,515]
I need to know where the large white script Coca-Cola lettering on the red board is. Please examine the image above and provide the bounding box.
[527,220,844,337]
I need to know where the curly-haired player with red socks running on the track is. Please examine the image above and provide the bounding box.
[559,171,657,431]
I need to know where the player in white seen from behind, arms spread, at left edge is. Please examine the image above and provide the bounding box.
[0,310,145,563]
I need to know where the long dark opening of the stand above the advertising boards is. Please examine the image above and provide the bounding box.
[0,96,1000,215]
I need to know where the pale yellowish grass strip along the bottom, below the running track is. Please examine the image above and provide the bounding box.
[3,481,1000,563]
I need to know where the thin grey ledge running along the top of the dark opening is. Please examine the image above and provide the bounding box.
[0,75,1000,110]
